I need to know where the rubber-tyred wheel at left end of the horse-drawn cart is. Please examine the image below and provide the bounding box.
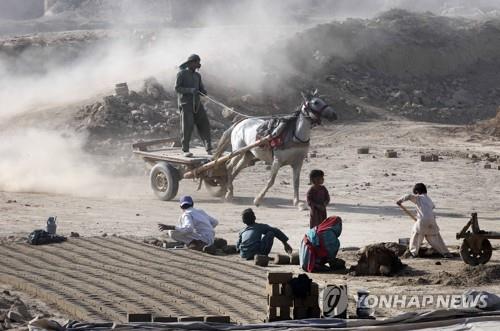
[149,162,179,201]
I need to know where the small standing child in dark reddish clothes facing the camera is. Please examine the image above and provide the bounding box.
[307,170,330,229]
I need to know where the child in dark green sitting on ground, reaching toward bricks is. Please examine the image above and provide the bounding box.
[236,208,293,260]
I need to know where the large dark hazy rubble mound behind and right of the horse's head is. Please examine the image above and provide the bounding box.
[275,10,500,124]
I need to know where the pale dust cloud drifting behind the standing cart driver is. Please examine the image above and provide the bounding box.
[0,0,498,194]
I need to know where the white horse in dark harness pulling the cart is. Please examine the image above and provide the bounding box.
[215,91,337,206]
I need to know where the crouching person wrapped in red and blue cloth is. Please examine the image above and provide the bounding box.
[299,216,345,272]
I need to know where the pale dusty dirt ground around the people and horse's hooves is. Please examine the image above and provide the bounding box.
[0,120,500,319]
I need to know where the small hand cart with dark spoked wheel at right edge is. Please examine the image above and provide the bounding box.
[457,213,500,266]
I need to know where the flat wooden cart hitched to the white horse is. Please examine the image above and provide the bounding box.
[132,137,269,200]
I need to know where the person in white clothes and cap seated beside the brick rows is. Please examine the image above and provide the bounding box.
[158,196,219,254]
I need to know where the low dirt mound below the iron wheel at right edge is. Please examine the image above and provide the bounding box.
[427,264,500,286]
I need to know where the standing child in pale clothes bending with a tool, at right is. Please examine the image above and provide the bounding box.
[396,183,451,257]
